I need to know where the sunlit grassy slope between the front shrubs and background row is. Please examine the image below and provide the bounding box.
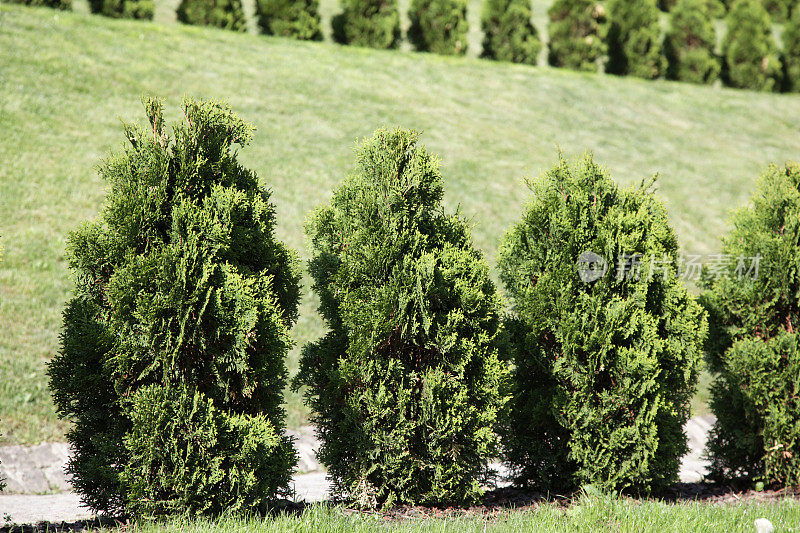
[0,4,800,443]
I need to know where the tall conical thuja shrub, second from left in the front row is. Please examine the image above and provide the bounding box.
[295,129,504,506]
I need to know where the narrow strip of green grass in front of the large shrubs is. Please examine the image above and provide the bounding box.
[87,497,800,533]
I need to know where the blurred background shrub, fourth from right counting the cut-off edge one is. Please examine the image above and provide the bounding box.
[606,0,666,79]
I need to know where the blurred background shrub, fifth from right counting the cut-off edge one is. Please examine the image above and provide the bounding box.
[547,0,608,72]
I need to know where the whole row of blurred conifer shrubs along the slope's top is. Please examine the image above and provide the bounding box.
[6,0,800,92]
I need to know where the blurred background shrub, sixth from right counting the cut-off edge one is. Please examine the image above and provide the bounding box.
[481,0,542,65]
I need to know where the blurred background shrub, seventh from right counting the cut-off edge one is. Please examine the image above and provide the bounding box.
[408,0,469,55]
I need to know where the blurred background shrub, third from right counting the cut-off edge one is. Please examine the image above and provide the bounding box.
[664,0,721,83]
